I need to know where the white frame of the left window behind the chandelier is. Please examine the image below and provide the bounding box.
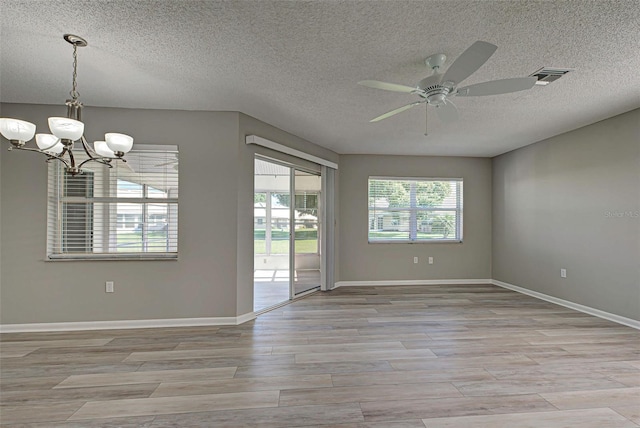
[45,144,179,261]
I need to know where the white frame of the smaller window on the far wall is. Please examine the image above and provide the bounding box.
[367,176,464,244]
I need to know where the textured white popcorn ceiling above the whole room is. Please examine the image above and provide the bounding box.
[0,0,640,156]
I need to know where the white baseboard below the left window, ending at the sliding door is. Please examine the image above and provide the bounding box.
[0,312,256,333]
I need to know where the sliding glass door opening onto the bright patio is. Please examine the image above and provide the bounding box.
[253,158,321,312]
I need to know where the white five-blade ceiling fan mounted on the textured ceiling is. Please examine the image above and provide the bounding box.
[358,40,536,129]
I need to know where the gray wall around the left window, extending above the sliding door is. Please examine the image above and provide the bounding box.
[0,104,337,324]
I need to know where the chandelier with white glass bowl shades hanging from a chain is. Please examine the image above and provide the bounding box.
[0,34,133,175]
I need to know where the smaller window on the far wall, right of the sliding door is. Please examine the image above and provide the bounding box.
[368,177,462,242]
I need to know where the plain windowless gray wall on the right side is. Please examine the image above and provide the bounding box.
[493,109,640,320]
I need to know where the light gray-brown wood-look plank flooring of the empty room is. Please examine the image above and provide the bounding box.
[0,285,640,428]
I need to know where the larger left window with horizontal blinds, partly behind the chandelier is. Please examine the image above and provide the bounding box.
[47,145,178,259]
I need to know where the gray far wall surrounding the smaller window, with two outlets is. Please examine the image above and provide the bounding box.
[339,155,491,281]
